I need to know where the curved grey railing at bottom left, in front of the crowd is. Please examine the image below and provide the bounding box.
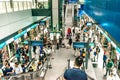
[1,60,48,80]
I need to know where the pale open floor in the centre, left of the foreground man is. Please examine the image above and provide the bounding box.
[45,48,74,80]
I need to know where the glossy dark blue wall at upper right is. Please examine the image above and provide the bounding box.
[84,0,120,43]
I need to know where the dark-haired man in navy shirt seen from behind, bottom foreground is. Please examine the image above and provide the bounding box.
[64,56,87,80]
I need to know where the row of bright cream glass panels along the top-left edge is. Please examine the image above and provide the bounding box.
[0,0,48,14]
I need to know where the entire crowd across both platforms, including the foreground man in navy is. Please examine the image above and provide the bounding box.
[0,11,120,80]
